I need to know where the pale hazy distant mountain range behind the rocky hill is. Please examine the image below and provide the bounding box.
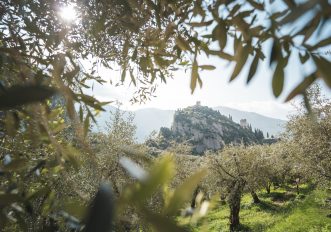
[93,106,286,142]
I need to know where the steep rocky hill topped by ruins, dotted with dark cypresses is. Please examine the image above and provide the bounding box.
[147,104,263,154]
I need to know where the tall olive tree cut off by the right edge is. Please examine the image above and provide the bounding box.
[284,85,331,184]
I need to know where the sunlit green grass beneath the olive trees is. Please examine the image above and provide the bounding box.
[182,186,331,232]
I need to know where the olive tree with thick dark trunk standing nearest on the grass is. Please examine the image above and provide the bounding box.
[207,147,266,231]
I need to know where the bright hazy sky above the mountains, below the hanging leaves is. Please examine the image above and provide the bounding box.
[86,46,331,119]
